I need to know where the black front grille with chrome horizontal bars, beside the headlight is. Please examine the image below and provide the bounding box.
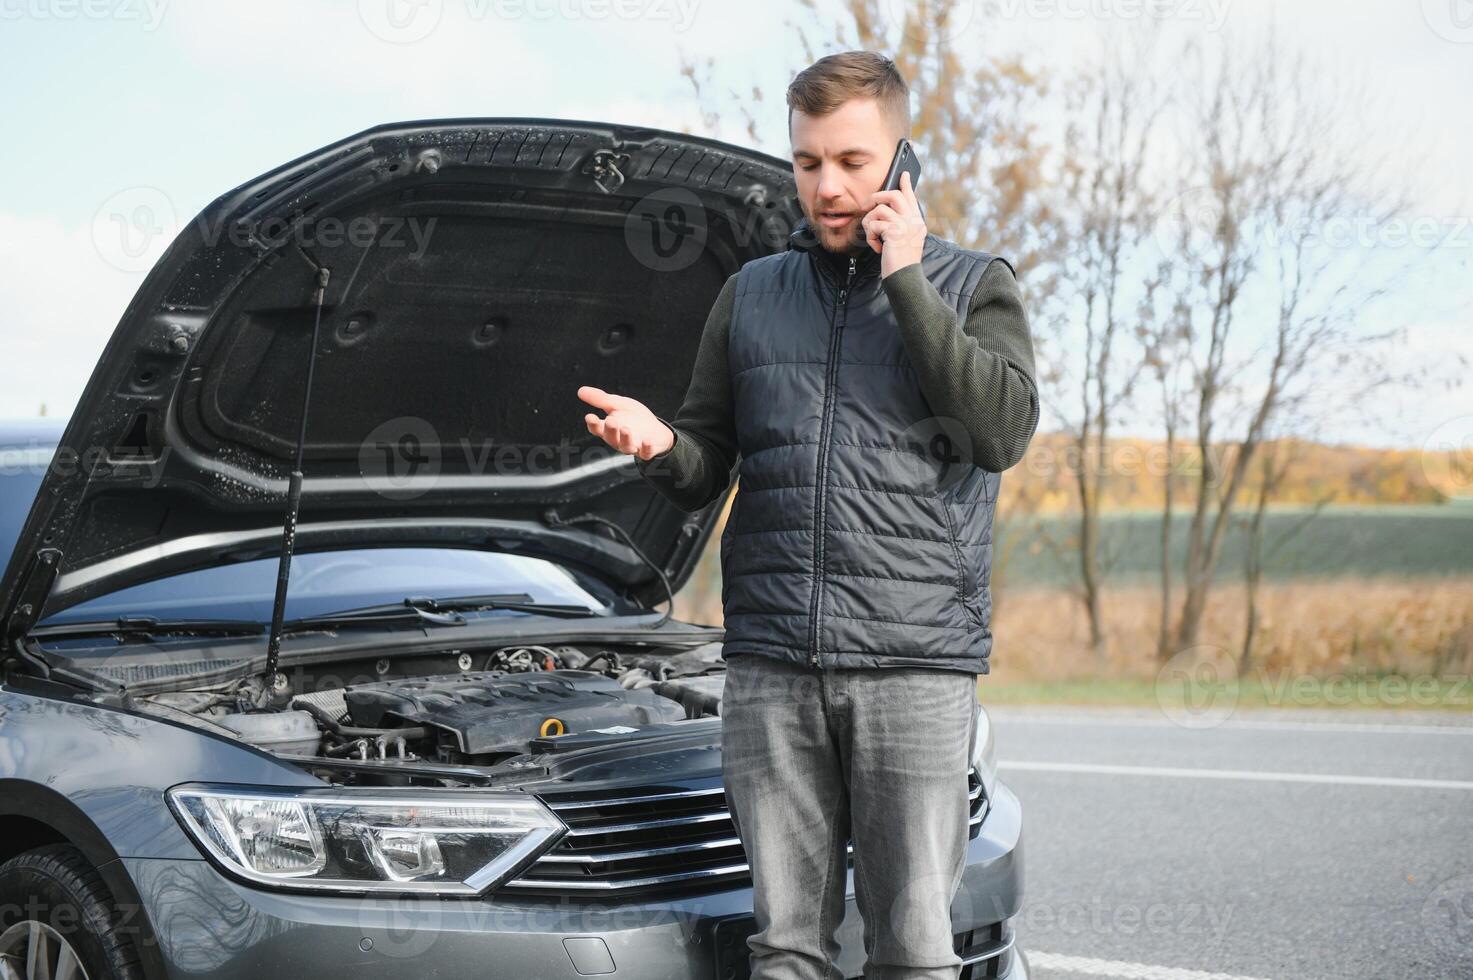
[501,771,987,897]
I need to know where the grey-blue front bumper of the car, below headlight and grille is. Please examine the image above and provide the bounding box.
[124,783,1027,980]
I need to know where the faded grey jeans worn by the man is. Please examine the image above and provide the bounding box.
[722,653,977,980]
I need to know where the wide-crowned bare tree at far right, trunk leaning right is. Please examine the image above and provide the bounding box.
[1174,35,1405,650]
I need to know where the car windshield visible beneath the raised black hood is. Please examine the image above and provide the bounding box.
[40,548,627,626]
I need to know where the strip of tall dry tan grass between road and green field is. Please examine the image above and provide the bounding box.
[980,576,1473,710]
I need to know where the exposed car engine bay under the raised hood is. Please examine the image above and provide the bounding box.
[147,643,725,766]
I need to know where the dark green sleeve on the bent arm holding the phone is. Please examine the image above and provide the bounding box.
[881,259,1038,473]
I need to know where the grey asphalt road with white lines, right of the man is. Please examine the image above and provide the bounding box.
[984,707,1473,980]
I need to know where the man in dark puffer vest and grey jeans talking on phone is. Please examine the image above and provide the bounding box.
[579,52,1038,980]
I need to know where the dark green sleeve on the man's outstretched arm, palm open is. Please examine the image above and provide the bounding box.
[635,274,737,513]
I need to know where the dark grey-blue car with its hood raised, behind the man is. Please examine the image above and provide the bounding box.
[0,119,1027,980]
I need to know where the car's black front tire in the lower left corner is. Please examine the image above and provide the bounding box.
[0,844,144,980]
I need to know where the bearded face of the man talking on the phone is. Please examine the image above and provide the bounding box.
[790,99,900,253]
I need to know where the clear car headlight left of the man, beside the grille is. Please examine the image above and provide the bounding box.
[166,785,567,895]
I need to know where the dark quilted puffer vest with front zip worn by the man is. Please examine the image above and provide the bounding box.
[720,221,1002,673]
